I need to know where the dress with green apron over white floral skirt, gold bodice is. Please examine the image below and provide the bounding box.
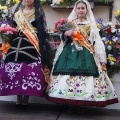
[48,21,118,106]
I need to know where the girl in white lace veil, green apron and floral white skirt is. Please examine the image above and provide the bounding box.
[48,0,118,107]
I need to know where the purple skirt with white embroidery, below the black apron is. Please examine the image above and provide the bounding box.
[0,58,46,96]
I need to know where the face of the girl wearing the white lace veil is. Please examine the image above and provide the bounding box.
[76,3,87,18]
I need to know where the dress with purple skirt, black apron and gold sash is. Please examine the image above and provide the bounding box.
[0,9,45,96]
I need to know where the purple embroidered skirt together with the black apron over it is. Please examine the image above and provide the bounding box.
[0,36,46,96]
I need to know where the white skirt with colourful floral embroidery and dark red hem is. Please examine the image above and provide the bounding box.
[48,70,118,107]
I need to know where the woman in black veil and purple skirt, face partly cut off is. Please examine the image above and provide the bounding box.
[0,0,51,107]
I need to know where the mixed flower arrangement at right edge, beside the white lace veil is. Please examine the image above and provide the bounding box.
[97,19,120,75]
